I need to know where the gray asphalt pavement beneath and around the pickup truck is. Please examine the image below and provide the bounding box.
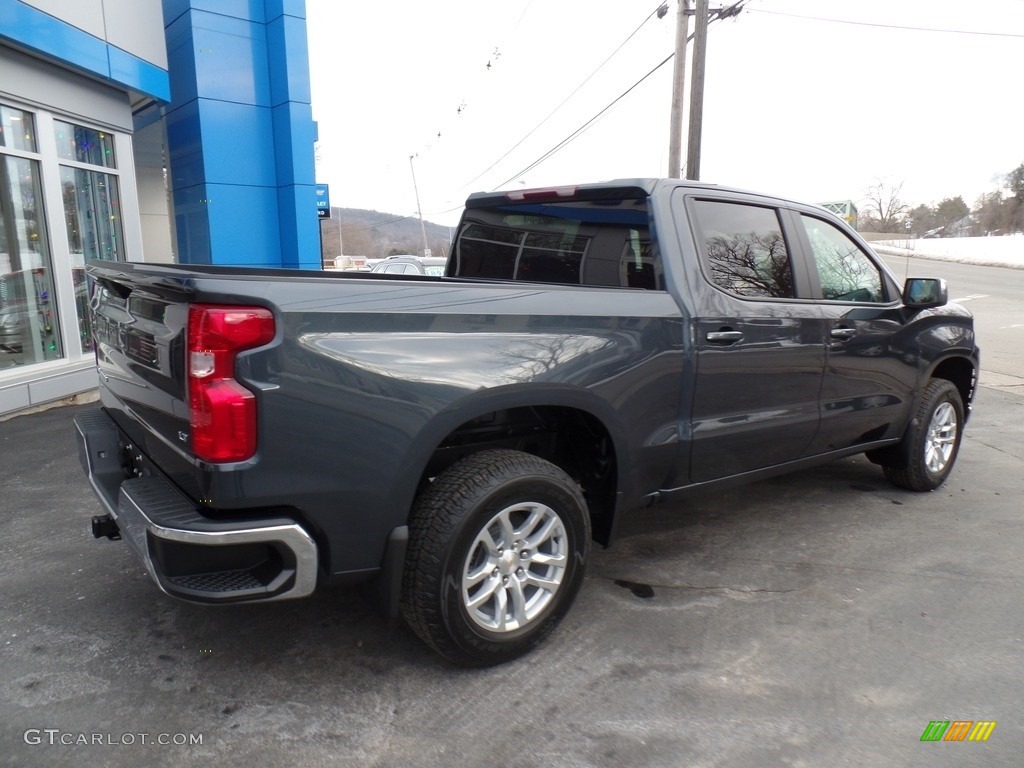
[0,388,1024,768]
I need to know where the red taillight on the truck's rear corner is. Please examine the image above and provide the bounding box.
[186,304,274,462]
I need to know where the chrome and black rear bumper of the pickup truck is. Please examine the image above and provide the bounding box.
[75,409,317,603]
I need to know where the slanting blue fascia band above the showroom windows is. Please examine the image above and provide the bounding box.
[0,0,171,100]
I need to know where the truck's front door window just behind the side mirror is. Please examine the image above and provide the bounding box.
[800,215,887,302]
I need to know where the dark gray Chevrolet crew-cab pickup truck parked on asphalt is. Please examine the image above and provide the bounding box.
[77,179,978,666]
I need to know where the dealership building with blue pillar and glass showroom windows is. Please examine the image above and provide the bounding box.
[0,0,321,416]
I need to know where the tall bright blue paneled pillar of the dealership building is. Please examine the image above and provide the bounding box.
[164,0,321,269]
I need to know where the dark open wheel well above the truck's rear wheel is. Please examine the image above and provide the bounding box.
[420,406,617,545]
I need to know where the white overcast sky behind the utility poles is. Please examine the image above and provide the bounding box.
[306,0,1024,224]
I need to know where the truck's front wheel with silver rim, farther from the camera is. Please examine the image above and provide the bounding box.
[882,379,964,490]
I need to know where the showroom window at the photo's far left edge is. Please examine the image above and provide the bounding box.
[0,104,63,369]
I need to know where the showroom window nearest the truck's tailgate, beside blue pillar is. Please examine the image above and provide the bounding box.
[53,120,125,352]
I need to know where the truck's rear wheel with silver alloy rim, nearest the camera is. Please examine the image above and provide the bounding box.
[401,451,590,667]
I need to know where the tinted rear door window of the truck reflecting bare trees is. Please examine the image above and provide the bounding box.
[693,200,797,299]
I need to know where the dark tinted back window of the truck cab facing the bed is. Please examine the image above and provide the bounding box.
[449,200,665,290]
